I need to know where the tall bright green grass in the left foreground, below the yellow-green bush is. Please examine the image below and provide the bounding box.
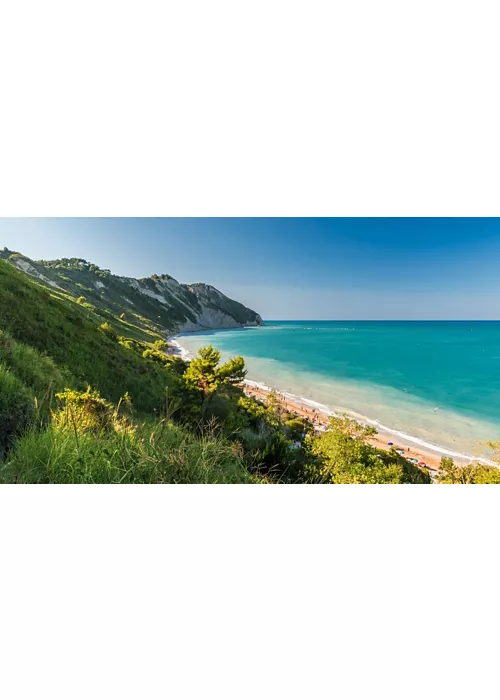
[0,421,255,484]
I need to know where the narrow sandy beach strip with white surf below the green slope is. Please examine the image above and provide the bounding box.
[168,333,498,473]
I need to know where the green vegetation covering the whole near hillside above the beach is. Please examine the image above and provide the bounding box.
[0,261,500,484]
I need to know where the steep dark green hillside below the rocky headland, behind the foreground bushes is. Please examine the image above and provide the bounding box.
[0,261,180,413]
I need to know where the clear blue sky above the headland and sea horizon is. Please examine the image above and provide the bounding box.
[0,219,500,319]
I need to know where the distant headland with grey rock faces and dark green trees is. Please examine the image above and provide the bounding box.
[0,248,263,334]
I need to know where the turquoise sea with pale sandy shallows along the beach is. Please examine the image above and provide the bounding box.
[178,321,500,457]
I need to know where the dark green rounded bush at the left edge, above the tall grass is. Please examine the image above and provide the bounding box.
[0,364,36,457]
